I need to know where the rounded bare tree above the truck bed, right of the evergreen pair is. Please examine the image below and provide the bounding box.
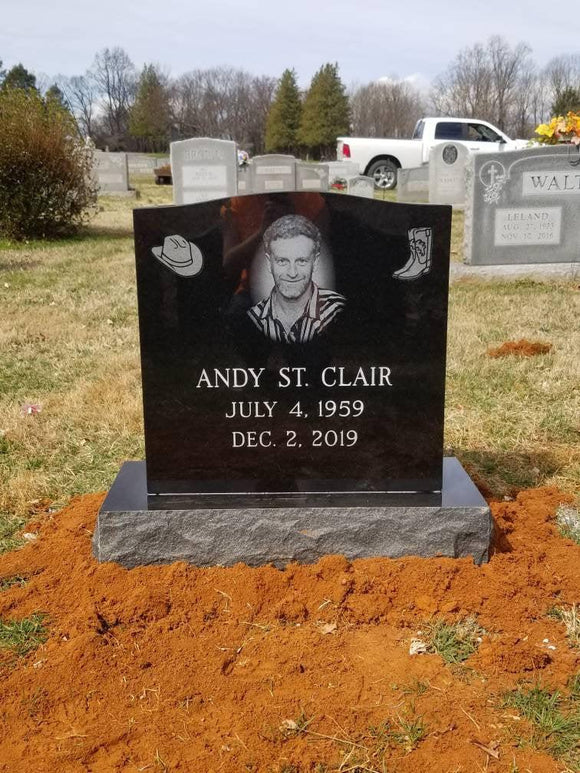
[350,79,425,137]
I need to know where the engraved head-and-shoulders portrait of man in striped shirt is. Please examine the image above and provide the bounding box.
[247,215,346,343]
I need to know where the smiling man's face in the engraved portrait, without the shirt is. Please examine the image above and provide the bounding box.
[268,234,318,300]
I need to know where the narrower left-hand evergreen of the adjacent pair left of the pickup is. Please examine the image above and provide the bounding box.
[266,70,302,154]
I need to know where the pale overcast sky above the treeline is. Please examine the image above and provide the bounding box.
[0,0,580,87]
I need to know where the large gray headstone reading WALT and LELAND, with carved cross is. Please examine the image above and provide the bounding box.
[465,145,580,265]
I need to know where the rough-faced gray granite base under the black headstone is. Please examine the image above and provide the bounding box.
[93,458,492,568]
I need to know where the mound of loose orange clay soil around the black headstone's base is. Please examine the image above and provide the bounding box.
[0,488,580,773]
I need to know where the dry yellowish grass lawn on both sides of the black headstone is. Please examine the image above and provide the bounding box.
[0,176,580,532]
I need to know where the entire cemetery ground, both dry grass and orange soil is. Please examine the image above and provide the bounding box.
[0,178,580,773]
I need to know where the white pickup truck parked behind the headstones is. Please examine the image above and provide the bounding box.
[336,118,528,190]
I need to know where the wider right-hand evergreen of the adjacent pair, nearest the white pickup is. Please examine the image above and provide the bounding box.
[298,64,350,158]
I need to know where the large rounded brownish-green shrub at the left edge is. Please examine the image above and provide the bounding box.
[0,88,96,239]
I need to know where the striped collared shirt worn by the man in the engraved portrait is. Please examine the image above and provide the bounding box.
[248,282,346,344]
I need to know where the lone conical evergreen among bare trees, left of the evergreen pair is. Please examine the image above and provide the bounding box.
[129,64,170,153]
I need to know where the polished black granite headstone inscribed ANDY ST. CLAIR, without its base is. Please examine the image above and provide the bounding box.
[97,193,492,563]
